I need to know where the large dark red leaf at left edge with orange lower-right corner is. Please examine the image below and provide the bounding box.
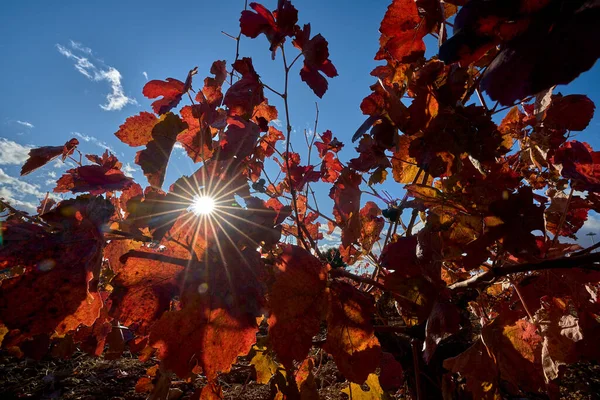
[0,197,114,342]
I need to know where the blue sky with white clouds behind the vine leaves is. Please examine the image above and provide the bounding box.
[0,0,600,247]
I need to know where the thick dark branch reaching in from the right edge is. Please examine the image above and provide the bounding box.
[448,253,600,290]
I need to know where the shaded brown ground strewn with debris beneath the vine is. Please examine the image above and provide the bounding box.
[0,350,600,400]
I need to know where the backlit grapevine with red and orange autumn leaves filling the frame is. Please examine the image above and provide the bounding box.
[0,0,600,400]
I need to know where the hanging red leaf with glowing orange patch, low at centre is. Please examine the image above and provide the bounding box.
[323,282,381,384]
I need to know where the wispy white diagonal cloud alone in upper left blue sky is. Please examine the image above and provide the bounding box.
[56,40,138,111]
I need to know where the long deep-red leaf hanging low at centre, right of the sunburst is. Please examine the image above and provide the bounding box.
[268,245,327,367]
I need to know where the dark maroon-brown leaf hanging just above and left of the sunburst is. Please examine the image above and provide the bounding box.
[135,113,187,188]
